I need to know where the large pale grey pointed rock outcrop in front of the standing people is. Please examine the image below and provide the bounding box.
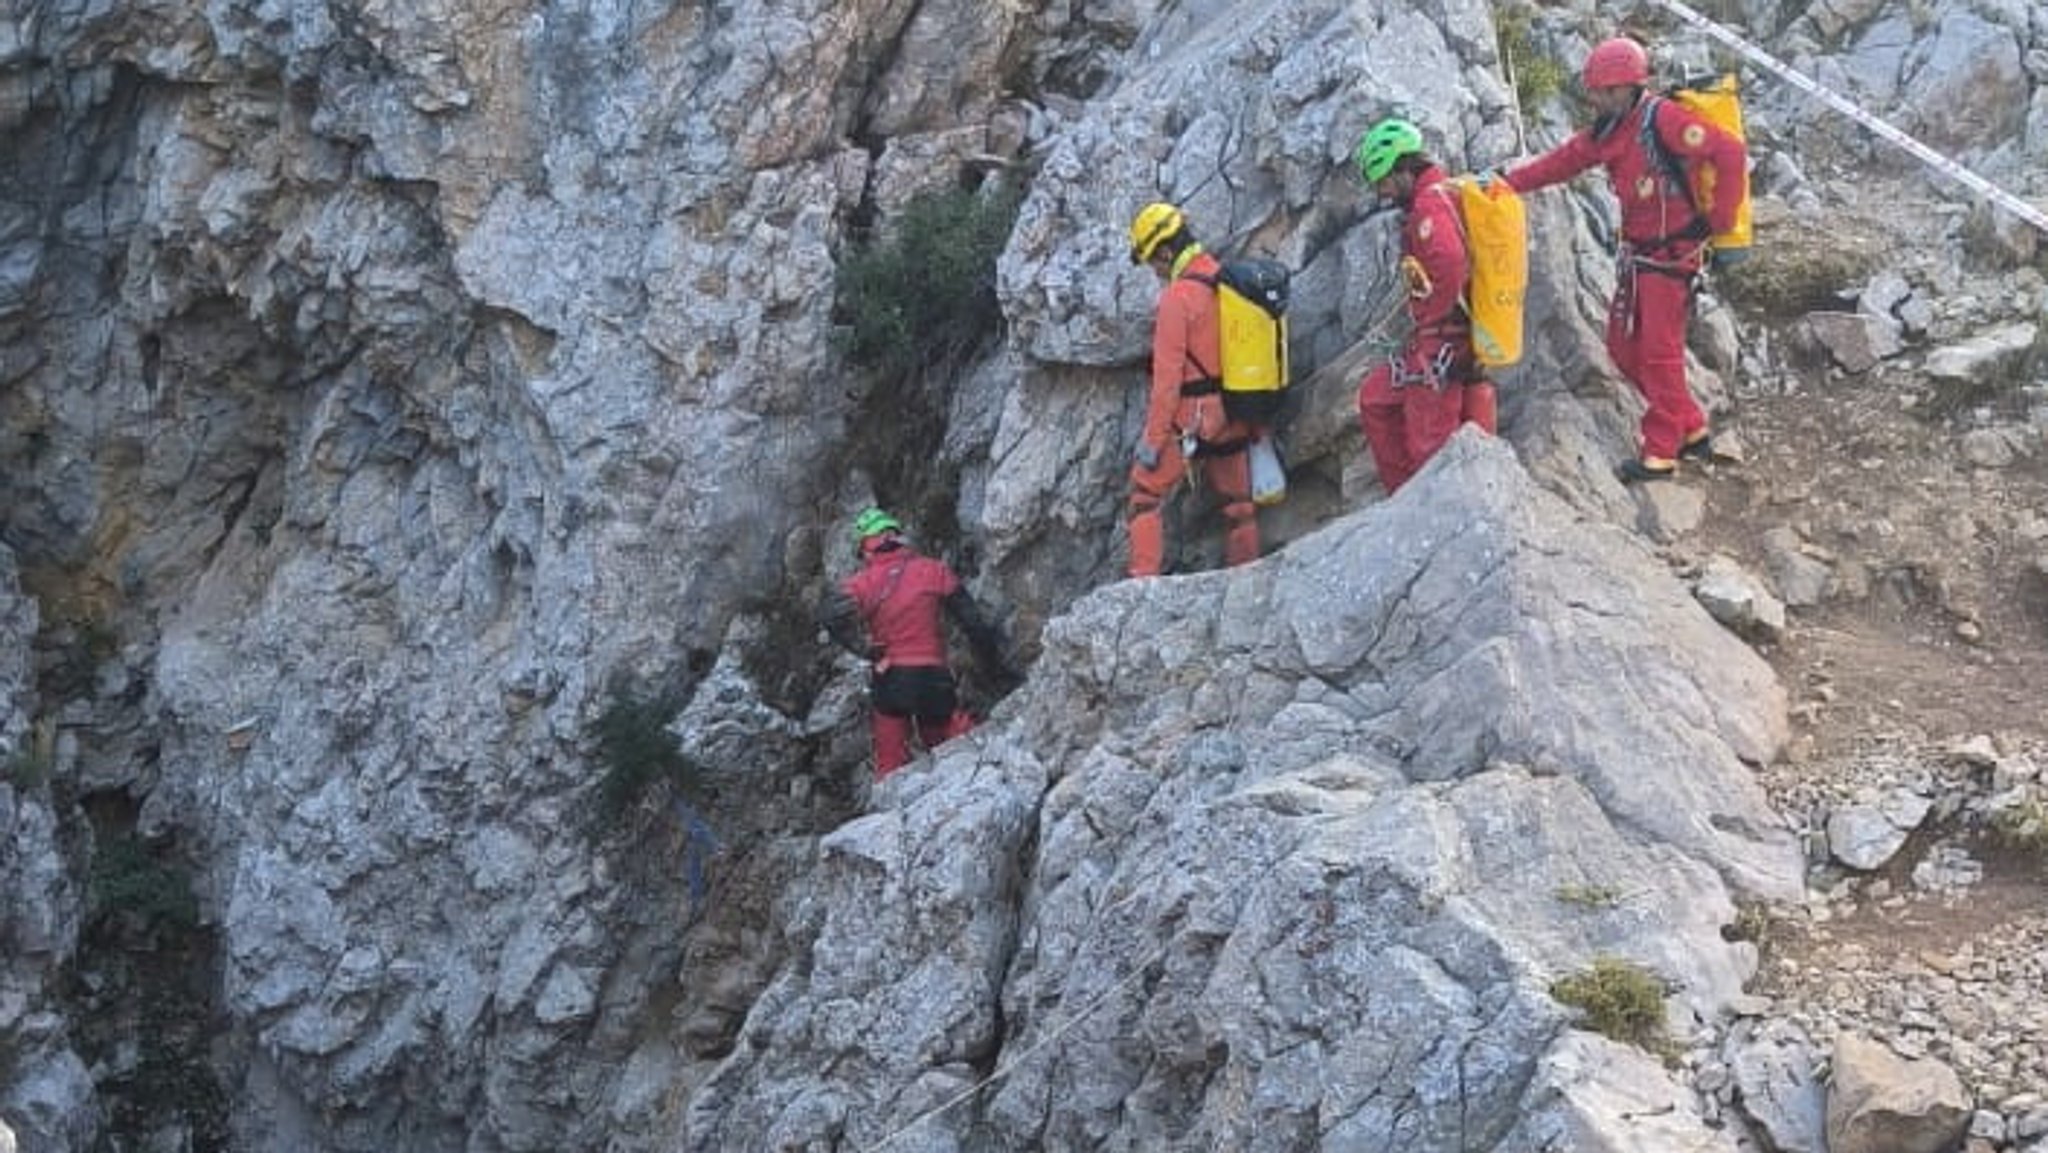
[686,434,1800,1151]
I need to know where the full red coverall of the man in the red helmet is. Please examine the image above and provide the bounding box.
[1505,96,1749,469]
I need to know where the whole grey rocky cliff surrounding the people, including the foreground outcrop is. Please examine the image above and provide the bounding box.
[0,0,2048,1153]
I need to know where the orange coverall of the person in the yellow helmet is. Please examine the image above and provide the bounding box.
[1130,248,1260,575]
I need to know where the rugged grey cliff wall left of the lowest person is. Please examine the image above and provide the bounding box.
[0,0,1040,1151]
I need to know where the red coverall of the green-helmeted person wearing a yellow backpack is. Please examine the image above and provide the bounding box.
[1358,164,1493,496]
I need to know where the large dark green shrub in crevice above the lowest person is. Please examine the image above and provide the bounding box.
[838,182,1018,375]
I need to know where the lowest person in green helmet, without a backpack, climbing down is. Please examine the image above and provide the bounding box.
[819,508,1020,780]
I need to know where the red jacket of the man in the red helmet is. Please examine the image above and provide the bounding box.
[1505,96,1749,248]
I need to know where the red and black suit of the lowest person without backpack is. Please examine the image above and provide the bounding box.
[840,541,975,778]
